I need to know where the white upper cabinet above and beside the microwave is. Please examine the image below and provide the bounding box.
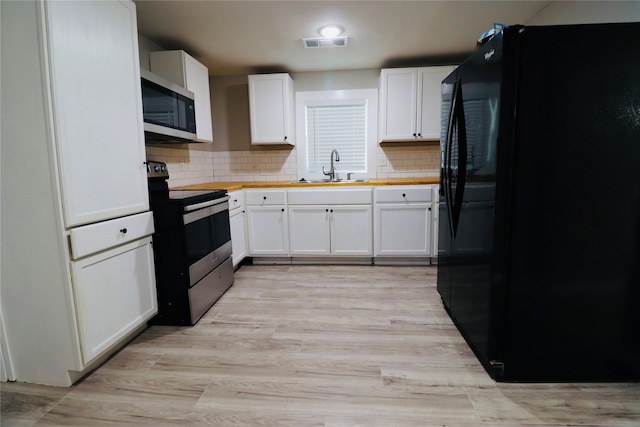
[149,50,213,142]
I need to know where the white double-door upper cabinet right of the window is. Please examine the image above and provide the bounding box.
[379,66,455,142]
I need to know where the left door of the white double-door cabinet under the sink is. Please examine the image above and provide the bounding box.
[289,206,331,255]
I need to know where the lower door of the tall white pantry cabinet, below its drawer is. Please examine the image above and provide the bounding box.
[71,237,158,365]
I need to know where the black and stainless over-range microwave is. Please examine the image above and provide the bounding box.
[140,69,196,143]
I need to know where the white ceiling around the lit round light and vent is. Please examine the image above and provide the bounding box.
[136,0,551,75]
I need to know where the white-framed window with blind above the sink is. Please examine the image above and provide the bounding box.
[296,89,378,179]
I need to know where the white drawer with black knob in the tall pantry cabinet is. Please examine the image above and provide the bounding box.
[71,212,154,259]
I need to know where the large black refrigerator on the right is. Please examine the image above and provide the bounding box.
[438,23,640,382]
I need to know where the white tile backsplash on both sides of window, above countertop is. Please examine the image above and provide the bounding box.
[146,145,440,187]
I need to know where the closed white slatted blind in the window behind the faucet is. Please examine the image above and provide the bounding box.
[305,100,367,173]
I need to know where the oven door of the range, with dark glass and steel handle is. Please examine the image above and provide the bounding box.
[183,196,231,286]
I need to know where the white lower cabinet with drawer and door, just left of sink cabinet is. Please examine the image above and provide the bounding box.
[245,190,289,256]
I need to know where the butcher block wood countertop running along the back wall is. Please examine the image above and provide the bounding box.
[171,177,440,191]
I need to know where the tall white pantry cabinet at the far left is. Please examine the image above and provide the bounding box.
[0,0,157,386]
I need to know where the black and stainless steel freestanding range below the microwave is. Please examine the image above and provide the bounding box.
[147,161,233,325]
